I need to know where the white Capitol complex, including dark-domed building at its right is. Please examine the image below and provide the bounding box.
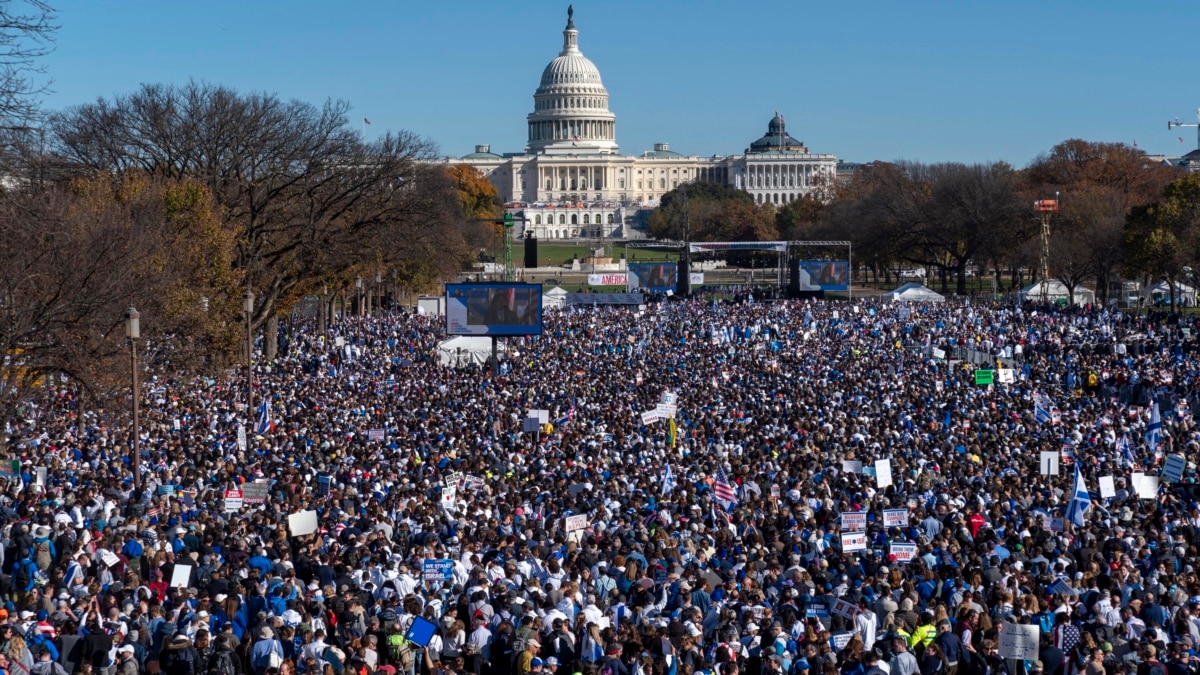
[448,8,838,239]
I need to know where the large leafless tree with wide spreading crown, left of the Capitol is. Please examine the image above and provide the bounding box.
[53,82,466,336]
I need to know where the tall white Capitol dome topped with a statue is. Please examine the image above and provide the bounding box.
[526,7,618,154]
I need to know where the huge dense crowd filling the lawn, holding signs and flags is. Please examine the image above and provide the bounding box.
[0,295,1200,675]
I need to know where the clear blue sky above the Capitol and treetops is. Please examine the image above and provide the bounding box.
[37,0,1200,166]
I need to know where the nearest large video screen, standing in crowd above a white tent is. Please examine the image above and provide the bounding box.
[446,283,541,335]
